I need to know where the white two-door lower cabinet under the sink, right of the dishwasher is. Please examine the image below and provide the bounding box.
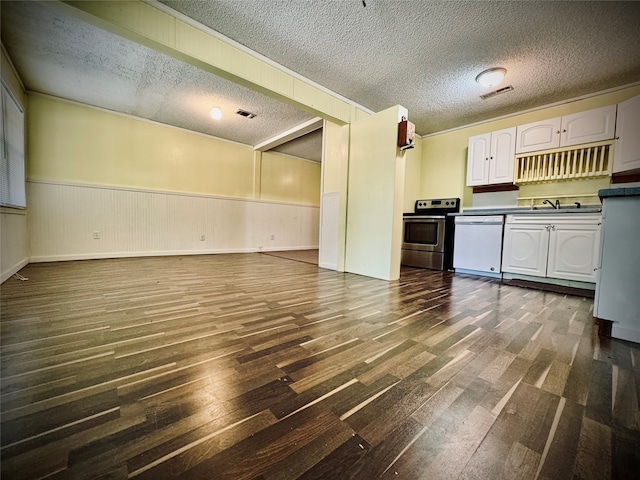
[502,213,602,283]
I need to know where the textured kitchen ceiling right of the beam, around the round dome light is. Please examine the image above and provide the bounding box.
[162,0,640,135]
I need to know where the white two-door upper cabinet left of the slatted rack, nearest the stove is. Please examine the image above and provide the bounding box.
[467,127,516,186]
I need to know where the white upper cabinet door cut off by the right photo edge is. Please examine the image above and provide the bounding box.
[613,95,640,173]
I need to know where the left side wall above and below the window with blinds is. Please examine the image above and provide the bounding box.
[0,49,29,282]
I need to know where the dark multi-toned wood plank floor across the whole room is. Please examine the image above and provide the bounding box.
[0,254,640,480]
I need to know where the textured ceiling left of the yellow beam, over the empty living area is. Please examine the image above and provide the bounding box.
[2,1,321,161]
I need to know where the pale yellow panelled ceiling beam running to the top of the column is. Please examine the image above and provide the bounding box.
[39,0,370,125]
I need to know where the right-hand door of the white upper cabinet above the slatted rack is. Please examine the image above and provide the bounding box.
[560,105,616,147]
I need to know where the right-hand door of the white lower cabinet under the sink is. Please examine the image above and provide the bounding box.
[547,222,600,283]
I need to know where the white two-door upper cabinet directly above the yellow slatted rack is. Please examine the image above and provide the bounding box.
[516,105,616,153]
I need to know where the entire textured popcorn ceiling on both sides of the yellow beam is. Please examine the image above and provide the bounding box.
[2,0,640,163]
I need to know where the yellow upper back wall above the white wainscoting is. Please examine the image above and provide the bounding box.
[27,94,320,205]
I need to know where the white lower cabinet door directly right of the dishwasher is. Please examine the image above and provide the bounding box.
[502,223,549,277]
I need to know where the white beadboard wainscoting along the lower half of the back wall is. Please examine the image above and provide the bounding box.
[27,181,319,262]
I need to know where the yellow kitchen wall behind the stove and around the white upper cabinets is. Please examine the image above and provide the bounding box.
[420,86,640,207]
